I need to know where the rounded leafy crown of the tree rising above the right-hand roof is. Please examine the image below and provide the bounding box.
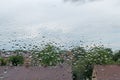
[85,46,112,65]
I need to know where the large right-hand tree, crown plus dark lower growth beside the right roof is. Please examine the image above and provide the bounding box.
[84,46,113,79]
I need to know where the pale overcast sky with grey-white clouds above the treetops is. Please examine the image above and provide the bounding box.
[0,0,120,49]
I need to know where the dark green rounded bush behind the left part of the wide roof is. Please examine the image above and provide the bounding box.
[9,55,24,66]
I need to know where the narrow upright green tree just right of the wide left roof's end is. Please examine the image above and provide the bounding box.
[71,46,86,80]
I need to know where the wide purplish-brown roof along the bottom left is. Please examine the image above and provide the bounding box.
[0,66,72,80]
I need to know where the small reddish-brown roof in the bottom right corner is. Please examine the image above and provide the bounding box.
[94,65,120,80]
